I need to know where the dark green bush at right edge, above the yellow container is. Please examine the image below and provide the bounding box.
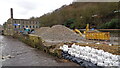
[100,19,120,29]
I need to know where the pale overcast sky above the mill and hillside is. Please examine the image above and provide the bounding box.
[0,0,73,24]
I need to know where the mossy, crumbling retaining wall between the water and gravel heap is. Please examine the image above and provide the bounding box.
[13,34,62,58]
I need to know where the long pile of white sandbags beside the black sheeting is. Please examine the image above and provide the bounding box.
[60,44,120,66]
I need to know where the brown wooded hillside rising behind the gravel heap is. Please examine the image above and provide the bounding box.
[34,2,118,29]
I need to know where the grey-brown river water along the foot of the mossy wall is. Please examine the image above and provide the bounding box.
[0,35,79,66]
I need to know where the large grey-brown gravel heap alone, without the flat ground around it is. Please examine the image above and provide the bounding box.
[37,25,82,42]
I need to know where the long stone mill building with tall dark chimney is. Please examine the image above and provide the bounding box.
[4,8,40,35]
